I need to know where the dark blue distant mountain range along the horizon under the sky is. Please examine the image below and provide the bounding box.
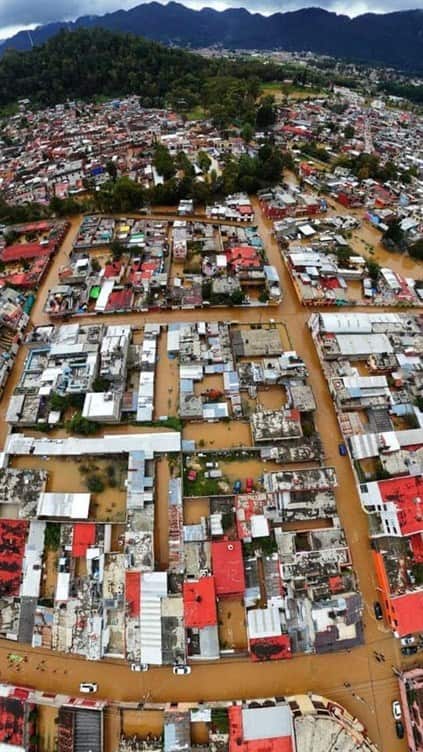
[0,2,423,72]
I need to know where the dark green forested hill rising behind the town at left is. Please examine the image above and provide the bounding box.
[0,28,312,126]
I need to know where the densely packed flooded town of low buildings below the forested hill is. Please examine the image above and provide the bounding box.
[0,50,423,752]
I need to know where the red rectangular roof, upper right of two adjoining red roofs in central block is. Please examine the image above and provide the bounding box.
[212,541,245,597]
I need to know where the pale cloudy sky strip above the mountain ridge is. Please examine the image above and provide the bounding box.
[0,0,423,38]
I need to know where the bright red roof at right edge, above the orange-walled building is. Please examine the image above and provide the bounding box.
[379,475,423,535]
